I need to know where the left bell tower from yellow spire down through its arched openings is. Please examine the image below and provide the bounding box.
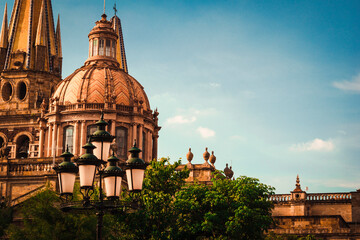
[0,0,62,159]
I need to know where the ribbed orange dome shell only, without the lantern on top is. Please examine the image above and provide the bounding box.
[53,61,150,110]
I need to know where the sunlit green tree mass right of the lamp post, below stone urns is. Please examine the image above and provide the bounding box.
[117,159,273,240]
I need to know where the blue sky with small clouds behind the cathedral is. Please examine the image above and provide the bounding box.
[0,0,360,193]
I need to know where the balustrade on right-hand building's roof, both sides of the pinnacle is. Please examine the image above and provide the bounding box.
[269,193,351,202]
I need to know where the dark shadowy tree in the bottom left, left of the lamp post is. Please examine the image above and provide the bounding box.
[7,189,96,240]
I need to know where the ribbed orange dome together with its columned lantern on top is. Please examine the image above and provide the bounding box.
[52,14,150,111]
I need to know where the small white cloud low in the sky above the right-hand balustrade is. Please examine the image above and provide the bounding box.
[290,138,335,152]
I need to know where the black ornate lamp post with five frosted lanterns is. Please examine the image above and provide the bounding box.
[54,114,147,240]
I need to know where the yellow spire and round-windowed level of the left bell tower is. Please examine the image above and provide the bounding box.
[0,0,62,112]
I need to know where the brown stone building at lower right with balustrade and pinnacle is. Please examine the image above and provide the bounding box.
[270,177,360,240]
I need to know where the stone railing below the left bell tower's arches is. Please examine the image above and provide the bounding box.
[0,158,62,176]
